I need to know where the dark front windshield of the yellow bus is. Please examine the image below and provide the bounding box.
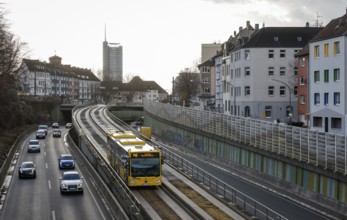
[131,158,160,177]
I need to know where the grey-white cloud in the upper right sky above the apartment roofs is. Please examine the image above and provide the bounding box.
[202,0,347,26]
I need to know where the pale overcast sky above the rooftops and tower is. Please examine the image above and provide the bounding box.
[0,0,347,93]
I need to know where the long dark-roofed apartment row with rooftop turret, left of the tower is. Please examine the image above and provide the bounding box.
[18,55,100,104]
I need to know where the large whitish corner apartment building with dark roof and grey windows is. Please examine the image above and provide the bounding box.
[223,25,322,121]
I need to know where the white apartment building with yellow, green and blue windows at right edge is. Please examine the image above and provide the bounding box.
[309,14,347,135]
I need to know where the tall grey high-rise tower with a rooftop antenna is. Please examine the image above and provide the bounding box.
[103,27,123,81]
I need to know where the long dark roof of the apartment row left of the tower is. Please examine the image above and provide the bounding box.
[23,59,100,81]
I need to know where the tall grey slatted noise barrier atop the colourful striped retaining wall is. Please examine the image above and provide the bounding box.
[144,101,347,175]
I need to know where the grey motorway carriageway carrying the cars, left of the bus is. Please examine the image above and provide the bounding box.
[0,126,112,220]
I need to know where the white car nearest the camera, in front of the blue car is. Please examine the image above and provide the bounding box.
[59,171,83,194]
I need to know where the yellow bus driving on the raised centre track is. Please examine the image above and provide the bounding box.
[107,130,163,187]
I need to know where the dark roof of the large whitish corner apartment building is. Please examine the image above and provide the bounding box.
[242,27,323,48]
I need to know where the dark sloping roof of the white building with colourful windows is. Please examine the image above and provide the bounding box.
[312,13,347,42]
